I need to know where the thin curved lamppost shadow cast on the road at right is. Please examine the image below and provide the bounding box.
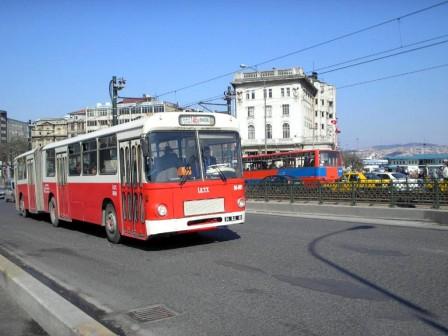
[308,225,448,334]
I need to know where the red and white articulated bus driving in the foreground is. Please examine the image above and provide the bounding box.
[15,112,245,243]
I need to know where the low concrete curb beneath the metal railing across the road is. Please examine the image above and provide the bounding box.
[246,200,448,228]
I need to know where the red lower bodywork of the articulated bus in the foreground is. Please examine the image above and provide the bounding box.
[18,179,244,238]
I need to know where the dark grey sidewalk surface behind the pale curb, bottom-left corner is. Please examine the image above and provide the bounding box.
[0,286,48,336]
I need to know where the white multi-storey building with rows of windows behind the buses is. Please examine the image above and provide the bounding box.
[232,67,337,154]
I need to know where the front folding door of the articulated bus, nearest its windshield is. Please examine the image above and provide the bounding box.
[120,139,146,237]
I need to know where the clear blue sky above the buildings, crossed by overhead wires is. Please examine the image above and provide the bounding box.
[0,0,448,148]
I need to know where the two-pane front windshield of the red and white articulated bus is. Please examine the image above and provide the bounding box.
[145,131,242,182]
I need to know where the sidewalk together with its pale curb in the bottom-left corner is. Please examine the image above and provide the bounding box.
[0,254,116,336]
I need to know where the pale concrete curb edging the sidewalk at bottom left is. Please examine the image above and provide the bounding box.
[0,255,117,336]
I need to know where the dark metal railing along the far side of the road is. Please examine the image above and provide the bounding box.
[246,180,448,209]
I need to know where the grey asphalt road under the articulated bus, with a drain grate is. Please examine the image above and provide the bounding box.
[0,202,448,336]
